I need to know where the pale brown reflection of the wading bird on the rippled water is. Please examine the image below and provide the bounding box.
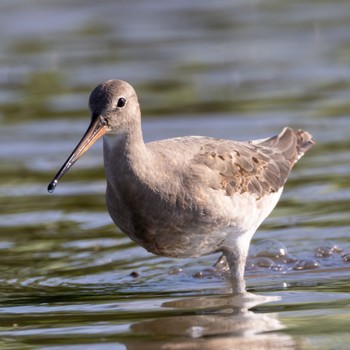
[125,294,296,350]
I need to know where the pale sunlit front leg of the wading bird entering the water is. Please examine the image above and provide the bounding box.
[223,245,249,294]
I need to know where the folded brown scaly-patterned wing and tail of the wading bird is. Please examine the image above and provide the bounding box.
[191,128,314,197]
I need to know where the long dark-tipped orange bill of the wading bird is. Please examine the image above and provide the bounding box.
[47,116,107,193]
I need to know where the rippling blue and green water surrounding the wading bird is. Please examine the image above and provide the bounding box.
[0,0,350,350]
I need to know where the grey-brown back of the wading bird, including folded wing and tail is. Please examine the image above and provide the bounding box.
[147,128,314,197]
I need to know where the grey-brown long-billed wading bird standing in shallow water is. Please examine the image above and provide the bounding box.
[48,80,315,295]
